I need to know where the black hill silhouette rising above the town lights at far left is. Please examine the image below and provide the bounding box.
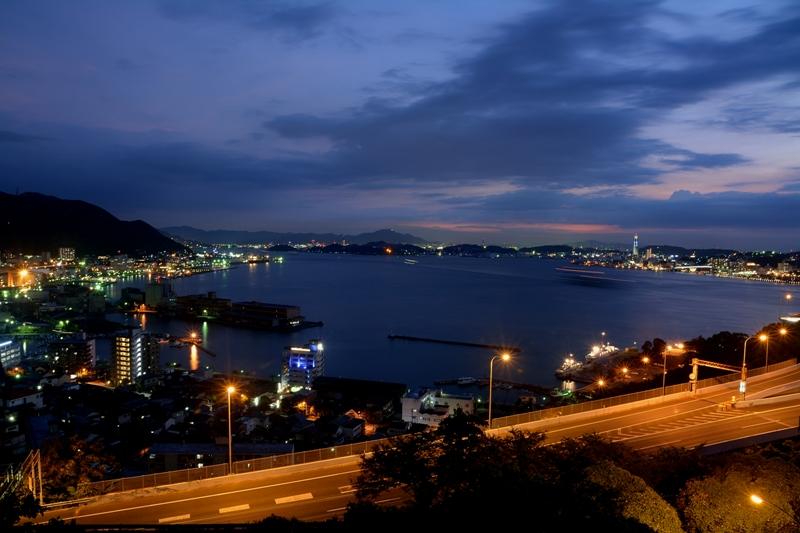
[0,192,186,256]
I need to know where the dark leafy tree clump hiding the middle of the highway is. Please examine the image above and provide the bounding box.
[352,414,680,532]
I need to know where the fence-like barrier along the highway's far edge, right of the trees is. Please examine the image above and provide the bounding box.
[492,359,797,429]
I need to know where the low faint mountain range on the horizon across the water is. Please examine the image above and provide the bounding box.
[161,226,427,244]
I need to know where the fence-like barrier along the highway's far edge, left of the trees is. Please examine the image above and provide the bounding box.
[78,439,389,495]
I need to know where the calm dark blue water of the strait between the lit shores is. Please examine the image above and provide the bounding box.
[111,253,796,385]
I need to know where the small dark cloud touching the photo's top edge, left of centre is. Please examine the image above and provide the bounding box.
[159,0,340,40]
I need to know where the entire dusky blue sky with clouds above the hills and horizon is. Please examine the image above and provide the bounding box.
[0,0,800,249]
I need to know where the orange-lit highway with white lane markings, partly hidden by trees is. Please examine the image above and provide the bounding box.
[37,366,800,524]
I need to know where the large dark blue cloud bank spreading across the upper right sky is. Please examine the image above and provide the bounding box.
[264,1,780,188]
